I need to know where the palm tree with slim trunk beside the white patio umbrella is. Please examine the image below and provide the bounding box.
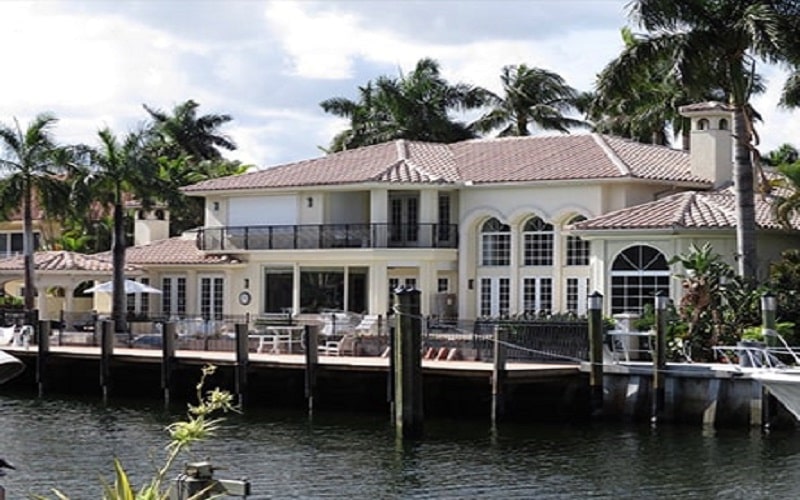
[78,128,158,332]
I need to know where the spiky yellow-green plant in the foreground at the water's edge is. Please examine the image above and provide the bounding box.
[37,365,238,500]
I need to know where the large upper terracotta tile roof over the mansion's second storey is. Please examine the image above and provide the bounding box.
[184,134,710,194]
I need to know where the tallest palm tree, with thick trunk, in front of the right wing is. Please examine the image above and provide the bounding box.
[606,0,800,278]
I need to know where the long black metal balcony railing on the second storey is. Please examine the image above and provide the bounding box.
[197,224,458,251]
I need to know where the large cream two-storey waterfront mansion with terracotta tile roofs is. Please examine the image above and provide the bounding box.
[3,103,800,319]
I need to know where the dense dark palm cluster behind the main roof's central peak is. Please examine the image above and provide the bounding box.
[320,58,488,152]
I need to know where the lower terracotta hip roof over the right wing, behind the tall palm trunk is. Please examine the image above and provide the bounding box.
[573,189,800,231]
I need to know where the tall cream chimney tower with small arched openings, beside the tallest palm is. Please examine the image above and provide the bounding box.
[679,101,733,188]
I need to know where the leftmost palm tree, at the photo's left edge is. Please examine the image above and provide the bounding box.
[0,113,67,311]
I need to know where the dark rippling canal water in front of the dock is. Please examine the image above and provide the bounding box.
[0,393,800,499]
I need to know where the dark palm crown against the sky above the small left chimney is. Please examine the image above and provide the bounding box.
[143,99,236,162]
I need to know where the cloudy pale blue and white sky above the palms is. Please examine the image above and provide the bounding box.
[0,0,800,168]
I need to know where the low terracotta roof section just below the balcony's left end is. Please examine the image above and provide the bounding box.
[116,237,237,266]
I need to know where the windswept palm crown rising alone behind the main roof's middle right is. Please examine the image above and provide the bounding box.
[472,64,587,137]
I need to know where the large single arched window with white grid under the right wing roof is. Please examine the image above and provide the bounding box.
[611,245,670,314]
